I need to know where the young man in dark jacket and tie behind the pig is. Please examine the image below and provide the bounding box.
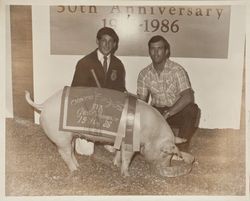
[71,27,126,92]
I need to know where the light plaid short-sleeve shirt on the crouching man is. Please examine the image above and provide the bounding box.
[137,59,191,107]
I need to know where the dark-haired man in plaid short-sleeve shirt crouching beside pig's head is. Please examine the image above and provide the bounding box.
[137,35,200,151]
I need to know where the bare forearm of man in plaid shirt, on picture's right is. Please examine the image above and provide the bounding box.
[164,88,194,118]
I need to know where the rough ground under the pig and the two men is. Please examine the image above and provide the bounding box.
[5,119,246,196]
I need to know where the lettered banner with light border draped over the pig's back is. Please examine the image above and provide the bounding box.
[59,87,139,149]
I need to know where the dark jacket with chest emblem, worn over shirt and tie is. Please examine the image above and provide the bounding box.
[71,49,126,92]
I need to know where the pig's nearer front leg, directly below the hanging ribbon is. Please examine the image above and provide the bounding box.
[121,143,134,177]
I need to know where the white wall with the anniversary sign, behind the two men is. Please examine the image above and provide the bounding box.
[6,2,246,129]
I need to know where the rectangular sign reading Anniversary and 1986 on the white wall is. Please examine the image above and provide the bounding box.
[50,5,231,58]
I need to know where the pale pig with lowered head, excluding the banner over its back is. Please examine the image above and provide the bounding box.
[25,90,193,177]
